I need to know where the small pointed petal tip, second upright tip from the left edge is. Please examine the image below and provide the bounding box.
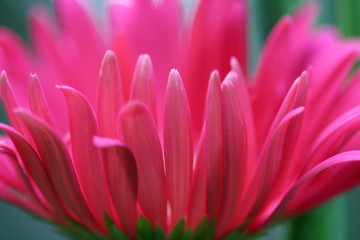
[29,74,54,128]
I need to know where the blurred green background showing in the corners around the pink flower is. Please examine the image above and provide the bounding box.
[0,0,360,240]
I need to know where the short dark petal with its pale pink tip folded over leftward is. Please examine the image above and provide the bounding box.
[94,137,138,237]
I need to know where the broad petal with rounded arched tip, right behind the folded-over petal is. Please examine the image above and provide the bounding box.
[119,102,167,228]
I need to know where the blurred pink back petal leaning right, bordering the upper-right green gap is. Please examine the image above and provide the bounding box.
[252,16,292,144]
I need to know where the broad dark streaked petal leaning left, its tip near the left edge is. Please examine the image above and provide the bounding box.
[16,110,94,228]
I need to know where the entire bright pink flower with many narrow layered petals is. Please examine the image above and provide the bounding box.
[0,0,360,237]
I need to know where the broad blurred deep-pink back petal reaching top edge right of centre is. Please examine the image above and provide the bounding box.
[181,0,247,138]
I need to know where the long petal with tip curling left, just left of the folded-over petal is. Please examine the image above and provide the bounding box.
[58,86,110,227]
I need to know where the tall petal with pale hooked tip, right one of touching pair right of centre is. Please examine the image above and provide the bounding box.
[217,72,248,235]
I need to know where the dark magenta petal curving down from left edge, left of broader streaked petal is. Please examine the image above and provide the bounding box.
[0,123,69,218]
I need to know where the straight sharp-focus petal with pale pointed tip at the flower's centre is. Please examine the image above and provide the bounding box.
[164,69,194,226]
